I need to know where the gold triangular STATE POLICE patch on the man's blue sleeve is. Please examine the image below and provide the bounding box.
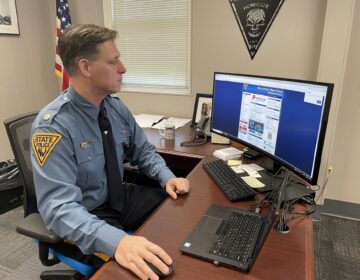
[31,132,62,166]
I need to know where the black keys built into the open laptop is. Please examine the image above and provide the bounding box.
[209,211,262,263]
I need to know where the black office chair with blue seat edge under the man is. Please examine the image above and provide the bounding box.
[4,112,95,280]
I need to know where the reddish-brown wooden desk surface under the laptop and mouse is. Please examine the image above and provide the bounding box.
[91,125,314,280]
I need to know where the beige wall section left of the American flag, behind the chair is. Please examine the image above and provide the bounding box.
[0,0,58,160]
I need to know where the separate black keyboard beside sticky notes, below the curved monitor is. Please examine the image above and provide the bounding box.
[203,159,256,201]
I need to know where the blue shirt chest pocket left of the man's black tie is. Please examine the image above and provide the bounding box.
[75,141,106,190]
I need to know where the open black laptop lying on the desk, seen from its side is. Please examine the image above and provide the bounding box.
[180,182,284,271]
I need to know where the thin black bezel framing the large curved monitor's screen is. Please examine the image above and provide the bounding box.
[210,72,334,185]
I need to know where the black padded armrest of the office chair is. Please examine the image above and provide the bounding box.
[16,213,63,244]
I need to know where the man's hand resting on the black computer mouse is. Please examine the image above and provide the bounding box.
[114,235,172,280]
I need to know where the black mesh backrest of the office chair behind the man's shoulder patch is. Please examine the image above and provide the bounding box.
[4,112,38,217]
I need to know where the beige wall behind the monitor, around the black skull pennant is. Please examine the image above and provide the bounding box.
[105,0,360,204]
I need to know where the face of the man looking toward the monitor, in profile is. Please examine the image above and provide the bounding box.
[89,41,126,94]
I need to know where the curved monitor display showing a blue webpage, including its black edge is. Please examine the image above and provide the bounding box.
[211,72,333,184]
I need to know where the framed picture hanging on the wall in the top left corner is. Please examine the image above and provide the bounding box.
[0,0,20,35]
